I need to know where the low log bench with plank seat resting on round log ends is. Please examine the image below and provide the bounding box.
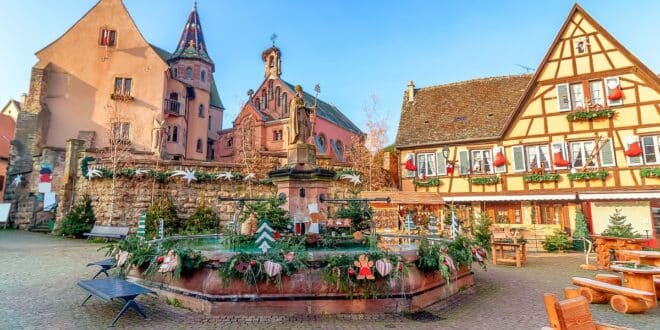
[572,277,657,314]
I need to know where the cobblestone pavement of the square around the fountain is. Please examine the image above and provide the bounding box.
[0,230,660,329]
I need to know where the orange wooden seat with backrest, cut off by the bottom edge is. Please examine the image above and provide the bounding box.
[543,293,627,330]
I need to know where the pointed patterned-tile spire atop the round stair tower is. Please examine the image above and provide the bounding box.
[170,1,213,65]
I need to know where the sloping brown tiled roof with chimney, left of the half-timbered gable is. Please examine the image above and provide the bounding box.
[396,74,532,148]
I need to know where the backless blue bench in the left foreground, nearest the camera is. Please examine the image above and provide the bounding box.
[78,278,156,327]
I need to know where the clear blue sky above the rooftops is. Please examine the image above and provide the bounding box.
[0,0,660,142]
